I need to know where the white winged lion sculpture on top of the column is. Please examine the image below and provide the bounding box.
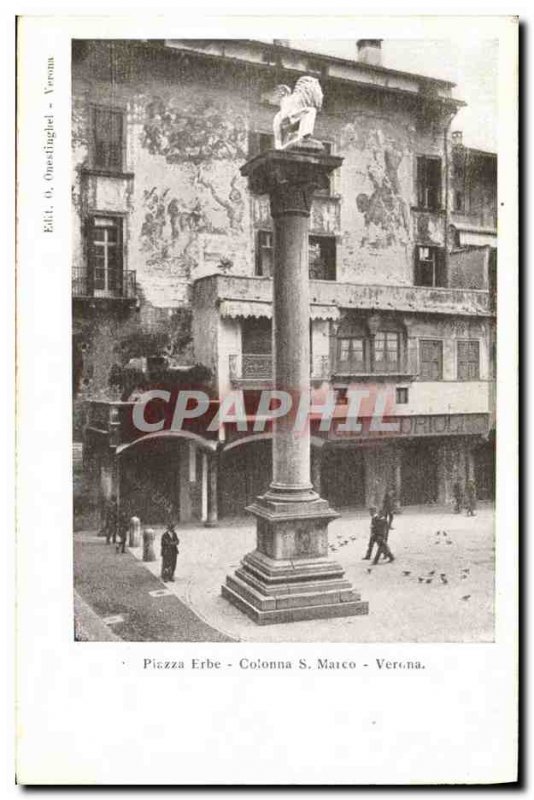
[273,75,323,150]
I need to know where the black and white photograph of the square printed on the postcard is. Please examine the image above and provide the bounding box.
[72,34,498,642]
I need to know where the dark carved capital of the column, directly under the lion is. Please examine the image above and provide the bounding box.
[241,144,343,217]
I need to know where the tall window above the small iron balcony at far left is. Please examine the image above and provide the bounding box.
[88,216,123,294]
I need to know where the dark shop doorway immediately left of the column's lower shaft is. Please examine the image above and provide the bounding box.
[219,439,272,517]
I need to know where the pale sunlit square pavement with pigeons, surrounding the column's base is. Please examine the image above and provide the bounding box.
[132,505,494,642]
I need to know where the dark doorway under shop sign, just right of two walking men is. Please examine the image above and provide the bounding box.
[401,442,438,506]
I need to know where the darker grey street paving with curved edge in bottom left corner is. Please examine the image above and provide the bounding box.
[74,533,234,642]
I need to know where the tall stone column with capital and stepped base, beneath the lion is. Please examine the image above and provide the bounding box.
[222,147,368,624]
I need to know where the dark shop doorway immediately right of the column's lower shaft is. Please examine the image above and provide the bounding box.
[321,447,365,508]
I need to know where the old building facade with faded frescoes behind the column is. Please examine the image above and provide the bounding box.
[73,40,496,523]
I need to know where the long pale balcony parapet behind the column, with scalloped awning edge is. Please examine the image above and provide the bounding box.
[193,275,493,319]
